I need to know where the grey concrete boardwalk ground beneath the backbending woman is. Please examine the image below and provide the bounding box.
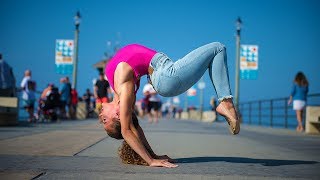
[0,120,320,179]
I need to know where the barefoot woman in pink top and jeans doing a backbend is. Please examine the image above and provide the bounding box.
[99,42,240,167]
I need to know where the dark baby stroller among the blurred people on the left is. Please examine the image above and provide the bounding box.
[39,87,61,121]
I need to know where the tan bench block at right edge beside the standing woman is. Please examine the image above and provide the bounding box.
[306,106,320,134]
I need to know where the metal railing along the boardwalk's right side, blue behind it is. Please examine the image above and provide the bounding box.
[239,93,320,128]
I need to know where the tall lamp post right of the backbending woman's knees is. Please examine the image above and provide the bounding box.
[235,17,242,109]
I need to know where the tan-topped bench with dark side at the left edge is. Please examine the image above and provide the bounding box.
[0,97,19,126]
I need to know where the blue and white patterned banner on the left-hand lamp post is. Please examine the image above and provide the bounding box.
[55,39,74,74]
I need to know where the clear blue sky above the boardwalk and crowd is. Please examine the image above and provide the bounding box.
[0,0,320,109]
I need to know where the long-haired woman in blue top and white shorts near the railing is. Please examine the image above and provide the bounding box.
[288,72,309,132]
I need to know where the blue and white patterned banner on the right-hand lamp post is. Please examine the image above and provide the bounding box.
[240,45,258,79]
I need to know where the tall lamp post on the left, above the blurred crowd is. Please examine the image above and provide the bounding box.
[72,11,81,89]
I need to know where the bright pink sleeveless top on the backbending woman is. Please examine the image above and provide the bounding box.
[105,44,157,93]
